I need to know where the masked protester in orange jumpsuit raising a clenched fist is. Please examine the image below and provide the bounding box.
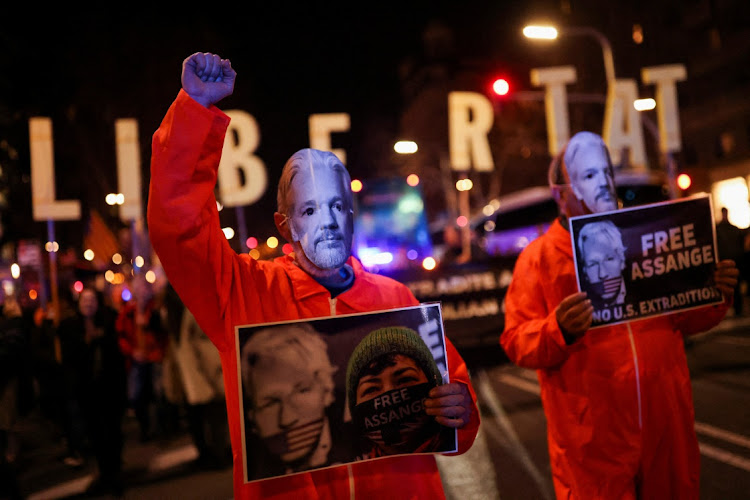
[148,53,479,499]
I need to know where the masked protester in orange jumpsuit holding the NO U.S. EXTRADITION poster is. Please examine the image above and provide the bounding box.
[500,132,738,500]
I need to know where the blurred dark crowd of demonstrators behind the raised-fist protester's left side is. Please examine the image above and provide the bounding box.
[0,268,231,499]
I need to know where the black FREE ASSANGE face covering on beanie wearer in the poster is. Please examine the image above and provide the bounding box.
[352,383,434,453]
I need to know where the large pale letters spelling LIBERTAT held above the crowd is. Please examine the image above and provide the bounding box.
[29,65,686,221]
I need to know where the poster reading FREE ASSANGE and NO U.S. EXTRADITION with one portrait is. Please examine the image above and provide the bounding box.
[569,194,723,328]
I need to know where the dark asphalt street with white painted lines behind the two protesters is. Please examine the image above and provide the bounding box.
[11,316,750,500]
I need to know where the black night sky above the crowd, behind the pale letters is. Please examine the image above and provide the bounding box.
[0,1,668,252]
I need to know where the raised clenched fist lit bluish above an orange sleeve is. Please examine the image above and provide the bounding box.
[182,52,237,107]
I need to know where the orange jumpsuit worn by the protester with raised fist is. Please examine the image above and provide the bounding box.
[148,90,479,499]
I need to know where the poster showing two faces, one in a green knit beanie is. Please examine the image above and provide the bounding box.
[235,303,458,482]
